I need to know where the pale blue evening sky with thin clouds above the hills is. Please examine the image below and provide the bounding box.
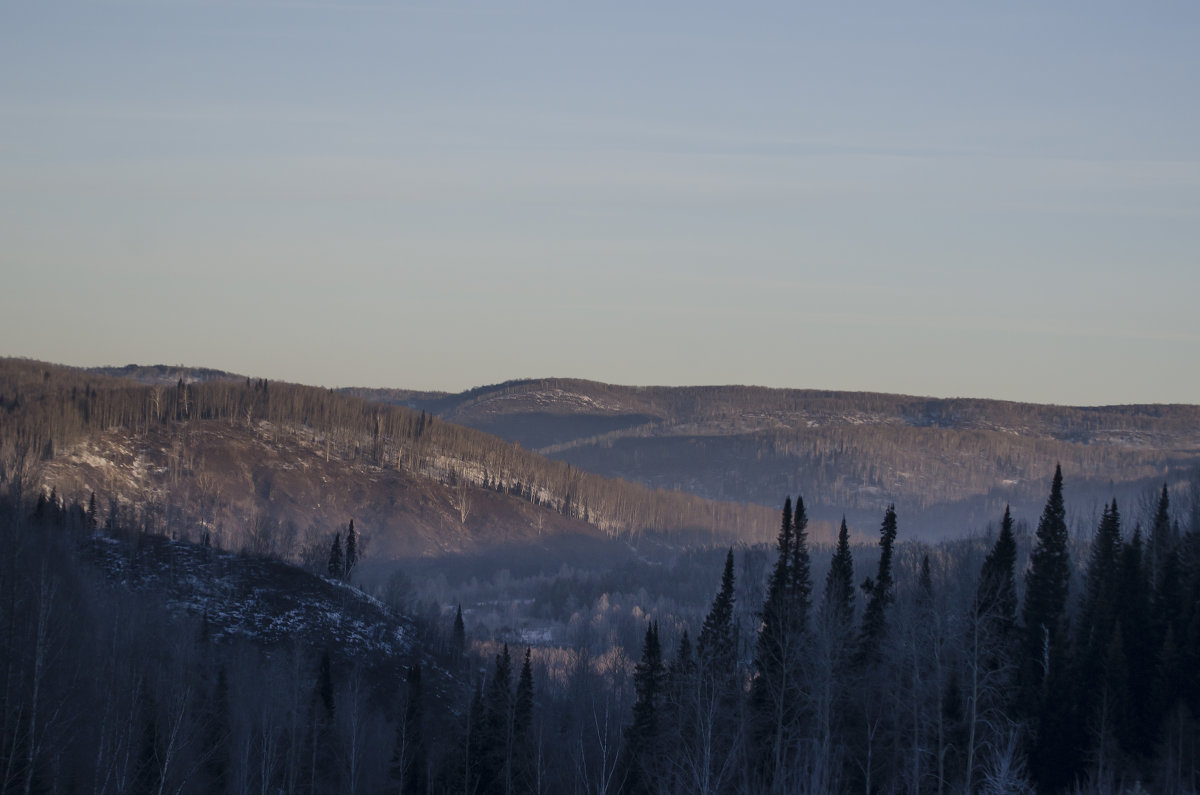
[0,0,1200,405]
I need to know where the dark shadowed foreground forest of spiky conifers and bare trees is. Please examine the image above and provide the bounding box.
[0,472,1200,793]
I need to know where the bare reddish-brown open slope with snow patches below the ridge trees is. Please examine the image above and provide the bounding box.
[40,420,600,560]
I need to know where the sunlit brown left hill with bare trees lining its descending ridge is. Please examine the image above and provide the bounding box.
[0,359,782,566]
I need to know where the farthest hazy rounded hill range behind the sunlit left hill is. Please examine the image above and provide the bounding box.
[347,378,1200,537]
